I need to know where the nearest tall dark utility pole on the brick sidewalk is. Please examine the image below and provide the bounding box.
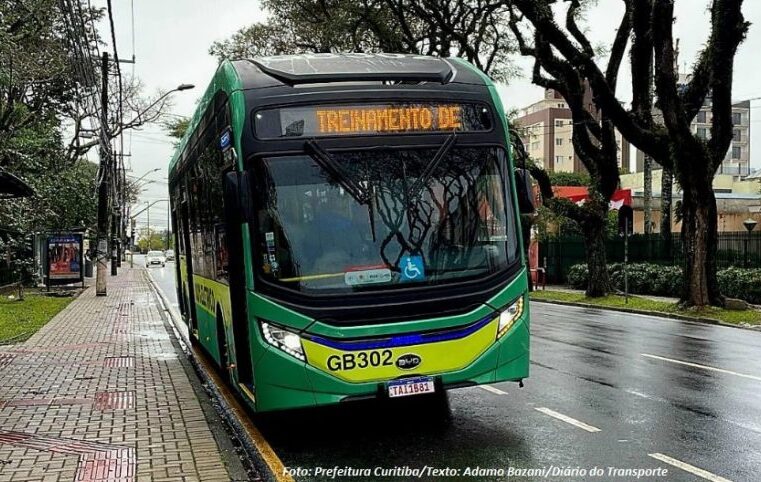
[95,52,111,296]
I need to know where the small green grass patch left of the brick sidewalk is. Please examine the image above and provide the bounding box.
[0,294,74,343]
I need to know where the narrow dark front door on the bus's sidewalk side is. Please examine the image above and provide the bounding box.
[224,170,254,389]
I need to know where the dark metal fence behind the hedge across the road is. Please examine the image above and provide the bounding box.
[539,231,761,283]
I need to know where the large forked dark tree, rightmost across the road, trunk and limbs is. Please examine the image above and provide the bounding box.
[513,0,748,306]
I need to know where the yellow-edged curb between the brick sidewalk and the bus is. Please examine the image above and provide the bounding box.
[146,274,294,482]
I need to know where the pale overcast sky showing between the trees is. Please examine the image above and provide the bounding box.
[96,0,761,227]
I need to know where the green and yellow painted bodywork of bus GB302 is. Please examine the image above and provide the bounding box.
[170,58,530,411]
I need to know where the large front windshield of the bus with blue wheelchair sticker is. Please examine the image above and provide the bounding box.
[254,147,518,293]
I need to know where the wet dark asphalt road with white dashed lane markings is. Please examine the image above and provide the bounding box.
[151,265,761,481]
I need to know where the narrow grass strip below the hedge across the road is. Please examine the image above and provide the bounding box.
[531,291,761,325]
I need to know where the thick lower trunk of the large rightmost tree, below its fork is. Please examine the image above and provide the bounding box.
[680,173,724,307]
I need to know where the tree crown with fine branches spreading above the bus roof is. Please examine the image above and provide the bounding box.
[210,0,515,80]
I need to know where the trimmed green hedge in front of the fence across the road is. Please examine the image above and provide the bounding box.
[567,263,761,304]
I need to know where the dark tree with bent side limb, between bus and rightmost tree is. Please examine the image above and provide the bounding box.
[509,0,631,296]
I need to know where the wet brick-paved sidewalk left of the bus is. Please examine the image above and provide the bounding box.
[0,268,230,482]
